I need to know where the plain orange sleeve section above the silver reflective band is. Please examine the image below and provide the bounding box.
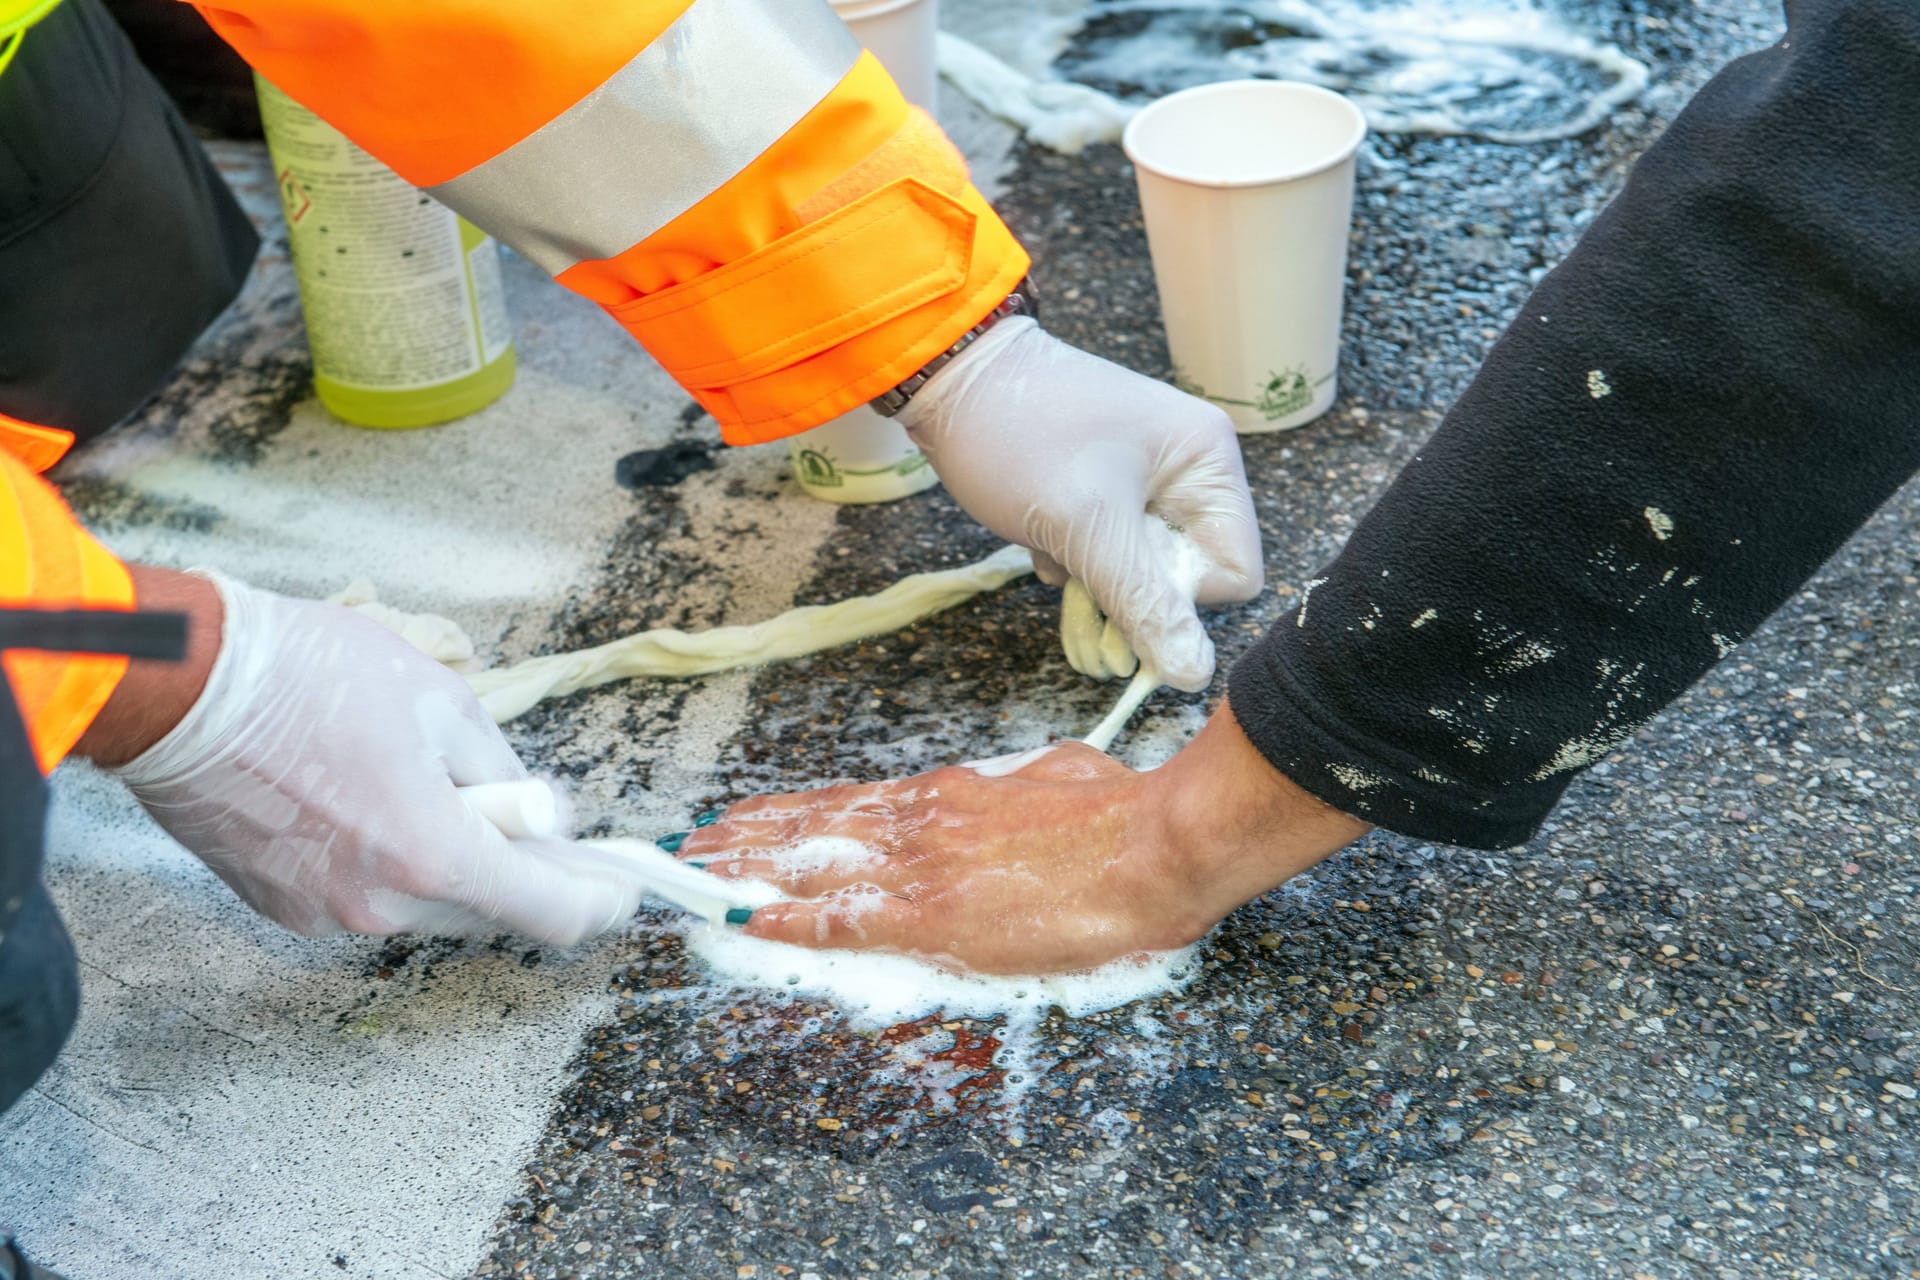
[194,0,691,186]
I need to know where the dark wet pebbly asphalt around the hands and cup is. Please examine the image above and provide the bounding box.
[0,0,1920,1280]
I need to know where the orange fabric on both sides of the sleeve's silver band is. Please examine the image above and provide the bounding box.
[202,0,1027,443]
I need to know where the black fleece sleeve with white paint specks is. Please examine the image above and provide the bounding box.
[1231,0,1920,848]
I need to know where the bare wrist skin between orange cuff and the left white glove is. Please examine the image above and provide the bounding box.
[73,564,225,768]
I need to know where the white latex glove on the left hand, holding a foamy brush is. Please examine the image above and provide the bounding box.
[115,578,641,944]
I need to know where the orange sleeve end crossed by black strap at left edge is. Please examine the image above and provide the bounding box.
[0,447,134,773]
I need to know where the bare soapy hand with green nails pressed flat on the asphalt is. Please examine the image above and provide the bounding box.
[682,706,1367,973]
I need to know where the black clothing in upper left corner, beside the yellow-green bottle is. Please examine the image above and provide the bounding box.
[0,0,259,439]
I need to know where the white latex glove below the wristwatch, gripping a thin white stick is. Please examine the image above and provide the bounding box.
[899,317,1263,691]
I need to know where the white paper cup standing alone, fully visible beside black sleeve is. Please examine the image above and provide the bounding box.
[1121,81,1367,432]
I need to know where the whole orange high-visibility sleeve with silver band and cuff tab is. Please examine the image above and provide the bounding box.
[198,0,1027,443]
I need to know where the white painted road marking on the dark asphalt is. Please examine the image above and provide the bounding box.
[0,70,1036,1280]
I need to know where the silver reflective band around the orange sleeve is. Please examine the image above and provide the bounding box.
[426,0,860,274]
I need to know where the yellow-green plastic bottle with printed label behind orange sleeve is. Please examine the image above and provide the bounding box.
[255,77,515,428]
